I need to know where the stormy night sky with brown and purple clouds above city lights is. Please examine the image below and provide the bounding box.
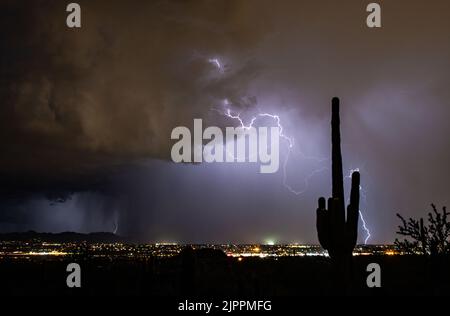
[0,0,450,243]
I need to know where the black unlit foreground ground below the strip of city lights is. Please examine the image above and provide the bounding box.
[0,251,450,297]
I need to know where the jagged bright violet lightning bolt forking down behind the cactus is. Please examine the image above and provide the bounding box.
[208,58,371,244]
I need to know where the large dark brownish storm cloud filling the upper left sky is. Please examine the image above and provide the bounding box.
[0,1,268,196]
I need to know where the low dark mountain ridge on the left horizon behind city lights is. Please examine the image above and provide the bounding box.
[0,231,126,243]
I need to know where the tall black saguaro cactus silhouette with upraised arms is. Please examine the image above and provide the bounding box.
[317,98,360,262]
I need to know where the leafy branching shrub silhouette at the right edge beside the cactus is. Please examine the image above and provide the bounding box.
[395,204,450,255]
